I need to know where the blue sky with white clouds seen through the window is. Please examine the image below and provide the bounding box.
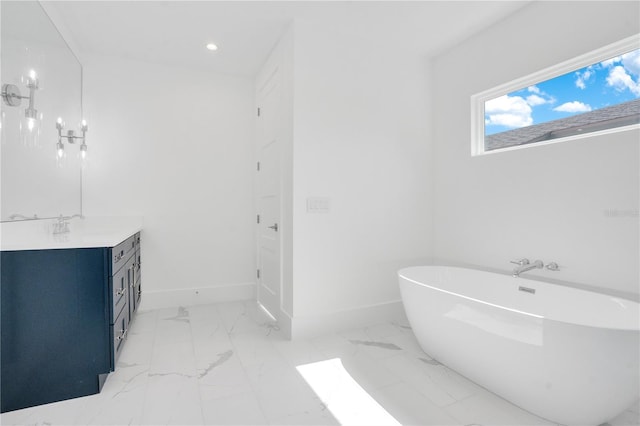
[485,49,640,135]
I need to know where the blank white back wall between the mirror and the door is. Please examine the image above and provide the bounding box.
[83,56,255,308]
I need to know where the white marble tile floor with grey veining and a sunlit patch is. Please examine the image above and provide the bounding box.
[0,301,640,426]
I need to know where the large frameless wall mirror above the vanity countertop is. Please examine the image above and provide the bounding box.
[0,1,82,221]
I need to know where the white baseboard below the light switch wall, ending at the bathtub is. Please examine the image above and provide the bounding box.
[291,300,406,340]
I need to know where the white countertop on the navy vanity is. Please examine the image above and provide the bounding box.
[0,217,142,251]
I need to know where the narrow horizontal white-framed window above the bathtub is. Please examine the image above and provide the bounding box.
[471,36,640,155]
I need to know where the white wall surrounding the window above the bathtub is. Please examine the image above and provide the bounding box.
[426,2,640,295]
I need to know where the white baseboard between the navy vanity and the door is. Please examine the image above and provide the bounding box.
[139,283,256,311]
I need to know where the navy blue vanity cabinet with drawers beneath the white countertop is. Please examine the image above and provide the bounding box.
[0,234,140,412]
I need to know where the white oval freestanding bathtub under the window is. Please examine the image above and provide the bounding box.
[398,266,640,425]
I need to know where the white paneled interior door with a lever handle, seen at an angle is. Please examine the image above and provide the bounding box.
[256,68,281,319]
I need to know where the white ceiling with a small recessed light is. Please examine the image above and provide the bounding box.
[47,1,528,75]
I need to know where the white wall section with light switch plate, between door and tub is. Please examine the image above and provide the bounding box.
[293,20,431,335]
